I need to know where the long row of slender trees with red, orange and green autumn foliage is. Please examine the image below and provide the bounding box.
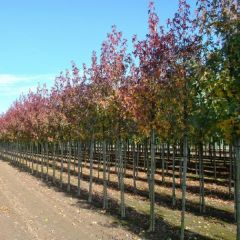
[0,0,240,239]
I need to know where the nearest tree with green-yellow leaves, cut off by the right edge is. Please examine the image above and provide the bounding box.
[198,0,240,239]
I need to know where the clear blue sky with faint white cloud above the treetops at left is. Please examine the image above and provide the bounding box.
[0,0,189,113]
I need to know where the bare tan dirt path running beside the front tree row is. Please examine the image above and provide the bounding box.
[0,161,138,240]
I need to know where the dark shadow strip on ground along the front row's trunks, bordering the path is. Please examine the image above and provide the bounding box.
[0,156,217,240]
